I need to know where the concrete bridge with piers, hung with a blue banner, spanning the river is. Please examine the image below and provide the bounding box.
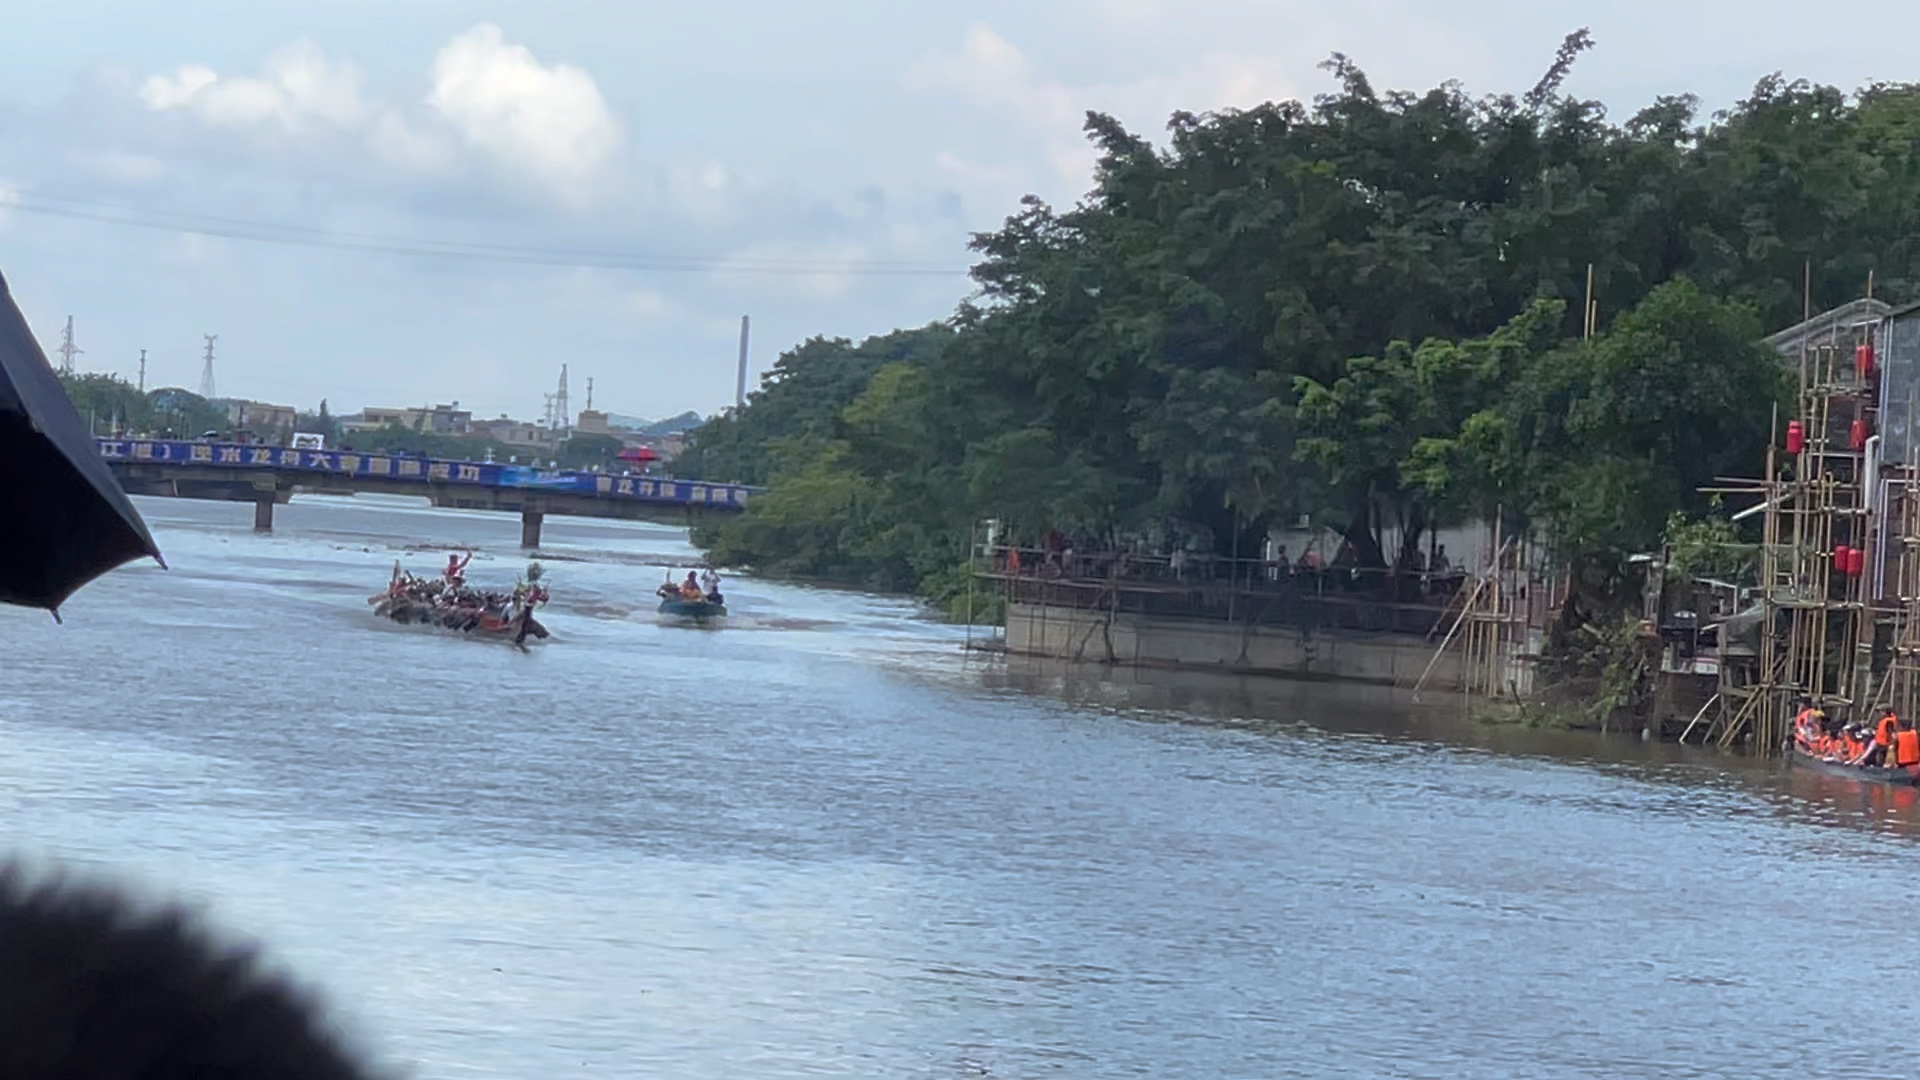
[96,438,758,548]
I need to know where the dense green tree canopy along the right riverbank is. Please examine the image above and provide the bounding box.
[689,31,1920,611]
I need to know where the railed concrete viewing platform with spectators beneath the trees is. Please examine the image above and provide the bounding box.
[973,546,1551,694]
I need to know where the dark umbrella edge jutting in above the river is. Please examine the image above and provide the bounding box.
[0,267,165,619]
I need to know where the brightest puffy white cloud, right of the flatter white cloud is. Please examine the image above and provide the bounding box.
[426,23,620,200]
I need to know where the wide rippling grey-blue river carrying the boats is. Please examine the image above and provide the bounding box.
[0,498,1920,1080]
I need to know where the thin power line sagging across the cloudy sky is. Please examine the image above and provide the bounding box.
[6,192,968,277]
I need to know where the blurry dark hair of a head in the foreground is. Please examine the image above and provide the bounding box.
[0,867,372,1080]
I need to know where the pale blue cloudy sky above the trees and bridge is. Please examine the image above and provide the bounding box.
[0,0,1920,417]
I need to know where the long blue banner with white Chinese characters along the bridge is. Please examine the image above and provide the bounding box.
[96,438,755,507]
